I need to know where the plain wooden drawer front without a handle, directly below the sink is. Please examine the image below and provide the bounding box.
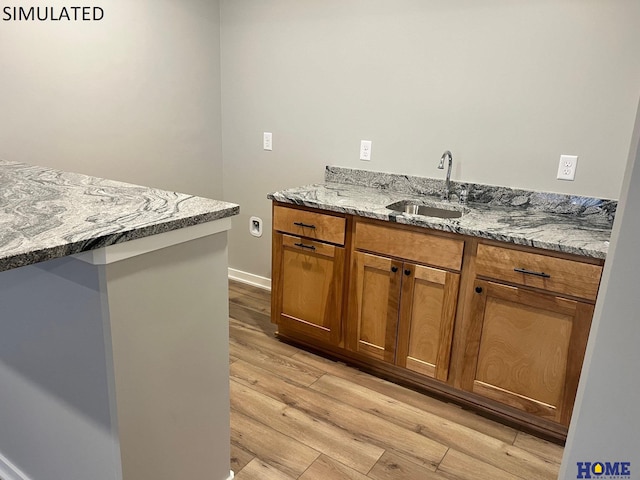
[355,222,464,270]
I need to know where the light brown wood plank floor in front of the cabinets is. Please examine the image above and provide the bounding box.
[229,281,563,480]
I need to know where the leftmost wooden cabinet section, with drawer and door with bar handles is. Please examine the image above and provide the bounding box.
[271,206,345,345]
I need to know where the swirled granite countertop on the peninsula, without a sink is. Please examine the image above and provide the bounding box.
[0,160,239,272]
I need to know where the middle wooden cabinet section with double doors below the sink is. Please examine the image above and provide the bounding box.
[347,222,464,381]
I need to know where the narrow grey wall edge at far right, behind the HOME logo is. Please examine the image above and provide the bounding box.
[559,100,640,479]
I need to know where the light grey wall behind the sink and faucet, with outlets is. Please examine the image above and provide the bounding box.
[220,0,640,277]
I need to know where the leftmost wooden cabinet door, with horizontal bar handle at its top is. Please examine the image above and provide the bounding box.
[273,234,344,345]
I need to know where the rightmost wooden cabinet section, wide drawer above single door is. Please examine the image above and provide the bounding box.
[463,244,602,425]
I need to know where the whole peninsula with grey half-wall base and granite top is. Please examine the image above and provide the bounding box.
[0,161,239,480]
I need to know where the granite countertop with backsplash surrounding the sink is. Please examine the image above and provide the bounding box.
[268,166,617,259]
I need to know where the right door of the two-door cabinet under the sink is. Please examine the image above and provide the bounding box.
[396,263,460,381]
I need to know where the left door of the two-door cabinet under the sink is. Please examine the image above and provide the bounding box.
[347,252,402,363]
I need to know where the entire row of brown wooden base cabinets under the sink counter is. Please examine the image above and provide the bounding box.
[272,203,604,439]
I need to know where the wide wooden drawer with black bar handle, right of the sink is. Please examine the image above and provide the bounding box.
[476,244,602,300]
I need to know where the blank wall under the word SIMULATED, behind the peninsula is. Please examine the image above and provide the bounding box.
[0,0,222,198]
